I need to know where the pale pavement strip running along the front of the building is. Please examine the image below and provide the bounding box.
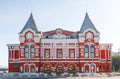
[0,73,120,79]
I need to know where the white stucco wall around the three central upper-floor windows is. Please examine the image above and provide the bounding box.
[41,39,78,59]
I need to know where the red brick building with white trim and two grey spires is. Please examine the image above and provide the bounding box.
[7,13,112,74]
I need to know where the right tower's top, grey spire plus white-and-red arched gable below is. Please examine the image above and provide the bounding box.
[79,13,100,42]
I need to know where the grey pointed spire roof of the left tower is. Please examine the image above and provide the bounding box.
[20,13,39,33]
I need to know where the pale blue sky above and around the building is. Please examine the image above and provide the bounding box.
[0,0,120,67]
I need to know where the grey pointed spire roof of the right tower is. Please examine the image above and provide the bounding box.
[80,13,99,33]
